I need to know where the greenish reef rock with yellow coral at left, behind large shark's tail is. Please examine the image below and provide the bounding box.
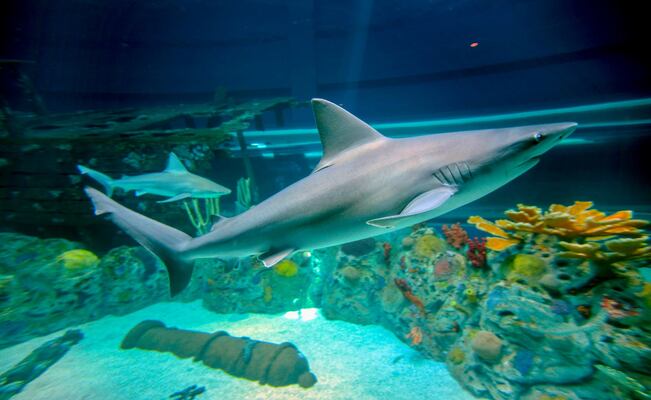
[0,233,169,347]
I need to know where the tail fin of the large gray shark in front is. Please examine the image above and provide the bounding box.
[84,187,194,296]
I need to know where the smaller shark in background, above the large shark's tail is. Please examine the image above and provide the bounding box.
[77,153,231,203]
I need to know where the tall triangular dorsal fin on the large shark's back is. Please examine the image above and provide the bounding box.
[312,99,385,171]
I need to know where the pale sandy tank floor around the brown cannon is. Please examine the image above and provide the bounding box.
[0,302,472,400]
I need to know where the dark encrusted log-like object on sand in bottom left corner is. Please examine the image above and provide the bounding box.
[0,329,84,400]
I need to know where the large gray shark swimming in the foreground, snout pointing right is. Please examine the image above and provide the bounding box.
[86,99,577,295]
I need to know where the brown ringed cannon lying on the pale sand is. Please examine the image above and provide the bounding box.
[120,320,316,388]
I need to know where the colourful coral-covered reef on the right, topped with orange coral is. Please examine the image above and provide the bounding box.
[323,202,651,400]
